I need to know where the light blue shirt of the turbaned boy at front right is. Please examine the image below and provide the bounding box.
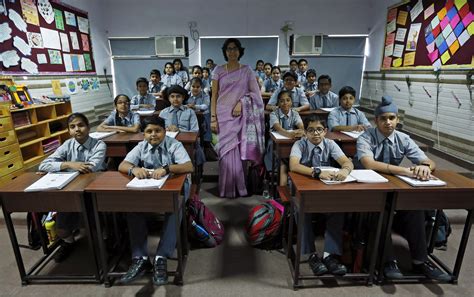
[356,128,428,166]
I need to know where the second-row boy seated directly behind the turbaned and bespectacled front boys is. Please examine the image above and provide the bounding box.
[328,86,370,131]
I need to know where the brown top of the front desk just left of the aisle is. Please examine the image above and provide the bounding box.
[84,171,186,193]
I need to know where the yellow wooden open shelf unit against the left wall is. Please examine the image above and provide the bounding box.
[11,102,72,169]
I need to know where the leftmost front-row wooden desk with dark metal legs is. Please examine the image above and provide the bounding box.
[0,172,100,285]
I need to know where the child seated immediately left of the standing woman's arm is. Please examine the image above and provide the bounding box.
[186,77,211,142]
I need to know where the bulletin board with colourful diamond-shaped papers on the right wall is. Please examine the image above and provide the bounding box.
[381,0,474,70]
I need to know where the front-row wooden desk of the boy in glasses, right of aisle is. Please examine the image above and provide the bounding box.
[287,172,394,288]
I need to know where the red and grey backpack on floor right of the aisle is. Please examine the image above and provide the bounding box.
[247,200,285,250]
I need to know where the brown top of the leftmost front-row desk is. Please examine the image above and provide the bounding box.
[0,172,100,194]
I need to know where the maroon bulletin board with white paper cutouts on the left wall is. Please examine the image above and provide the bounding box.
[0,0,95,75]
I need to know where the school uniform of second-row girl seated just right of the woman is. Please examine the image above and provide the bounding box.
[264,108,303,171]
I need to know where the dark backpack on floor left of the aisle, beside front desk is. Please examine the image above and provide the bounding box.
[186,194,224,247]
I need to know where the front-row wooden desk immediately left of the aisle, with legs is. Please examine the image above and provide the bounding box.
[85,171,188,286]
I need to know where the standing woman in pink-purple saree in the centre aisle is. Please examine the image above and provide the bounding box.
[211,38,265,198]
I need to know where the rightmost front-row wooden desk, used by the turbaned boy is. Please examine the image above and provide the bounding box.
[379,170,474,283]
